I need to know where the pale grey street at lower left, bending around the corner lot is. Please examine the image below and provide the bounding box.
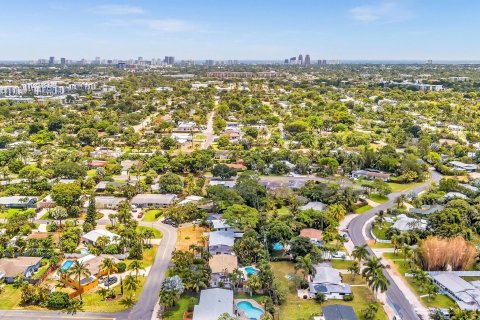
[0,221,177,320]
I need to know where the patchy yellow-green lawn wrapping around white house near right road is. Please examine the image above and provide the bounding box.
[271,261,387,320]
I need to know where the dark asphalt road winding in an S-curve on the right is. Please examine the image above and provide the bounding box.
[347,171,443,320]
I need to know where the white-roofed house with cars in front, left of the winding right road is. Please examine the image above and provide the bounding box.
[308,263,352,300]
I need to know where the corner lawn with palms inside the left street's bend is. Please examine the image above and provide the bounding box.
[83,276,146,312]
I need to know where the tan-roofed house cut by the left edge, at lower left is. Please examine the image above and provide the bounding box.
[0,257,42,284]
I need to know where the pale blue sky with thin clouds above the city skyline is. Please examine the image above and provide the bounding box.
[0,0,480,60]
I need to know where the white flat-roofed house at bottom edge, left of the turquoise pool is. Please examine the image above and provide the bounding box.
[192,288,234,320]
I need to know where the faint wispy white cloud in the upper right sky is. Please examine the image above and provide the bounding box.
[350,2,413,23]
